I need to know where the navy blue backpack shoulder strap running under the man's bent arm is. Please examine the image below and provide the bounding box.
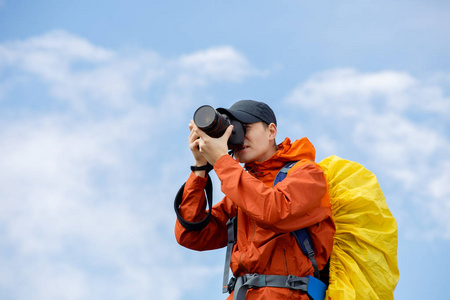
[273,161,320,279]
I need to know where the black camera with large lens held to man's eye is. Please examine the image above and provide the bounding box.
[194,105,245,151]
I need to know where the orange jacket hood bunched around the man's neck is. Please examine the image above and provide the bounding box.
[245,137,316,177]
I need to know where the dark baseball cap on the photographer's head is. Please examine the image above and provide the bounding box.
[217,100,277,125]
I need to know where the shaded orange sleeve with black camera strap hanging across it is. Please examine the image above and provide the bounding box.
[175,173,236,251]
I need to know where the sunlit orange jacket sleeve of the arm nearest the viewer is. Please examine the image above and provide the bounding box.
[214,156,331,233]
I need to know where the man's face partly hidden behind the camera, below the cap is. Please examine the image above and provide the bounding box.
[234,122,276,163]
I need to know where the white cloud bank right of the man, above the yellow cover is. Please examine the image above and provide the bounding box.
[285,69,450,239]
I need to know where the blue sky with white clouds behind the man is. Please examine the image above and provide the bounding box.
[0,0,450,300]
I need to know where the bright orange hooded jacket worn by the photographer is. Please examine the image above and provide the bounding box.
[175,138,335,300]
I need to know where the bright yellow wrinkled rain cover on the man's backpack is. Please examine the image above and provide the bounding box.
[319,156,399,300]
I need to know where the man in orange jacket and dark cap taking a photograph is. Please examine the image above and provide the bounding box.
[175,100,335,300]
